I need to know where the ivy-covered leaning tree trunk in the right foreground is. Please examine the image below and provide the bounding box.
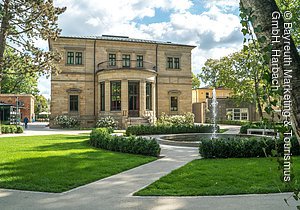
[240,0,300,140]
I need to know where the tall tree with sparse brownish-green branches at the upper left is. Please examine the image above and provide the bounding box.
[0,0,66,92]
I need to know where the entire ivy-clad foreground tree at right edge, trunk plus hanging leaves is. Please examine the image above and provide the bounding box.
[240,0,300,141]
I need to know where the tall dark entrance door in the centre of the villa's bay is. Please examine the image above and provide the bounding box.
[128,82,140,117]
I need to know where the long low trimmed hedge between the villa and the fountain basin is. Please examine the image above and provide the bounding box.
[126,125,220,136]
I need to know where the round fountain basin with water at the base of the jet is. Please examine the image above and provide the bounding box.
[151,133,270,147]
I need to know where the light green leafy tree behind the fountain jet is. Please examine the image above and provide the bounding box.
[200,44,268,119]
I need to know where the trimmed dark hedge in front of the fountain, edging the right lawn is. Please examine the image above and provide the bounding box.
[199,137,300,158]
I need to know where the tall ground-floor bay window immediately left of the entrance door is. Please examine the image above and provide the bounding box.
[110,81,121,111]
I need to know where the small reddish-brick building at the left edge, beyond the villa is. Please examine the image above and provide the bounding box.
[0,94,35,122]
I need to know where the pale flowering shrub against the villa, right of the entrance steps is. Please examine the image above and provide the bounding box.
[157,112,195,126]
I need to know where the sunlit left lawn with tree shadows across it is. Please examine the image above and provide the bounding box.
[0,135,156,192]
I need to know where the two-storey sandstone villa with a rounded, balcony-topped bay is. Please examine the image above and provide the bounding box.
[49,35,195,128]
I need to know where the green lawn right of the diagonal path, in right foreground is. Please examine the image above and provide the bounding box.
[135,157,300,196]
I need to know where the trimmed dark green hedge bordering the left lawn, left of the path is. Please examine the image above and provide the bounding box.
[89,128,160,157]
